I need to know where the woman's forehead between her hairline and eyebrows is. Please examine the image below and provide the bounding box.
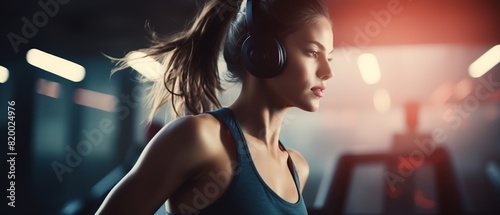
[285,16,333,49]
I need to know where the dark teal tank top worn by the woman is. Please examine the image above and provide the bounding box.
[176,108,307,215]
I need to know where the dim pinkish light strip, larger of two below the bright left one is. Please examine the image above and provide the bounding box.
[73,89,118,112]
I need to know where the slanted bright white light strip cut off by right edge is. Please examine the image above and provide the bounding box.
[469,45,500,78]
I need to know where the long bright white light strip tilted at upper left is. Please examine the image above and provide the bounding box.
[26,49,85,82]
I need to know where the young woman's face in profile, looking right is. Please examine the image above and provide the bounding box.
[268,16,333,111]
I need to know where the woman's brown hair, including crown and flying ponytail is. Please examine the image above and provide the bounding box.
[112,0,329,122]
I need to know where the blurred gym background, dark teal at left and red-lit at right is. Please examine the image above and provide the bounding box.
[0,0,500,214]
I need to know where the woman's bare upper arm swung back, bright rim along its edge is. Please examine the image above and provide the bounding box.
[97,116,214,214]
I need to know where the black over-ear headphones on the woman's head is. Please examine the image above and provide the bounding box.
[241,0,286,78]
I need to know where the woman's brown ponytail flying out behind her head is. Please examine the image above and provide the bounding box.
[112,0,242,123]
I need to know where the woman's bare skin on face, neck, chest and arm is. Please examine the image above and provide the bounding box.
[97,16,333,214]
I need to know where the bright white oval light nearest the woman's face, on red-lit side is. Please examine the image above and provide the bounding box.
[358,53,380,84]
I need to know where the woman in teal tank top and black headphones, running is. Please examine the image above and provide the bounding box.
[97,0,333,215]
